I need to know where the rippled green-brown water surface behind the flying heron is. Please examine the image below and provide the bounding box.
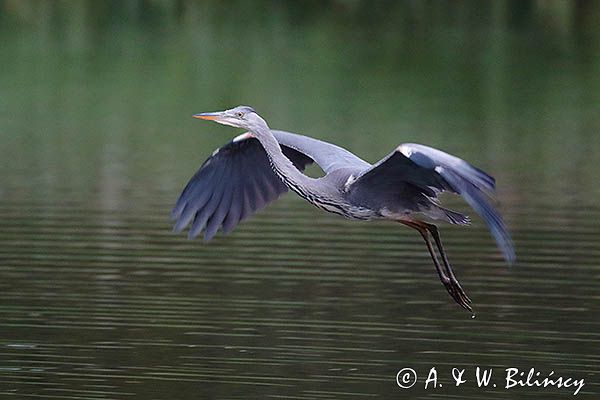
[0,2,600,399]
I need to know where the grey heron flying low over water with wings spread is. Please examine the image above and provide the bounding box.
[172,106,515,311]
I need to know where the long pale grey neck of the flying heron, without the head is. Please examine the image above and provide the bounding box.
[252,120,319,198]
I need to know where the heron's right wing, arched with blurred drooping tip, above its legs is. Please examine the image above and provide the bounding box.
[348,143,515,264]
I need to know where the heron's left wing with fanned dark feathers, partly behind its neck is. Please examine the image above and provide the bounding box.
[171,134,313,241]
